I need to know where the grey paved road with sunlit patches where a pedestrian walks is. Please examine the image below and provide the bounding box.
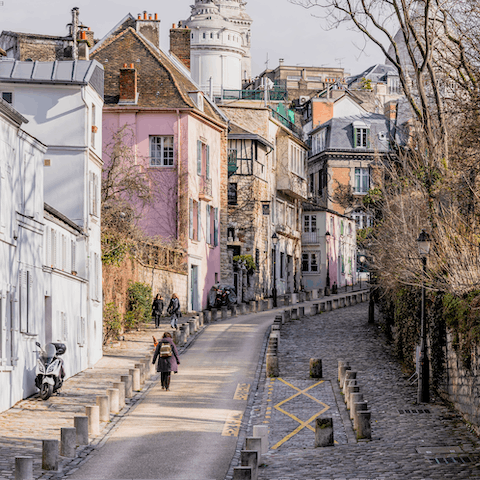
[69,312,273,480]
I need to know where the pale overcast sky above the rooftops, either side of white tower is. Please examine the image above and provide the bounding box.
[0,0,384,75]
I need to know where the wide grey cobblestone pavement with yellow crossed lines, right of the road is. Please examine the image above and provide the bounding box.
[248,303,480,480]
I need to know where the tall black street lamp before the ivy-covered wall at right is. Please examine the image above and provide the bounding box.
[417,230,431,403]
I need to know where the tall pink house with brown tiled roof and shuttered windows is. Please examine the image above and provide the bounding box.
[91,14,231,311]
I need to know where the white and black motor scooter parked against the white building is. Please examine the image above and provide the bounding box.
[35,342,67,400]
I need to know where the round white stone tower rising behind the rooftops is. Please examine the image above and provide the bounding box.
[183,0,252,95]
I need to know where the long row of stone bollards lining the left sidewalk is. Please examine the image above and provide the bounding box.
[15,354,155,480]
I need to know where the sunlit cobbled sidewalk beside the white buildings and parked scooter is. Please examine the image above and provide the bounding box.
[0,319,188,480]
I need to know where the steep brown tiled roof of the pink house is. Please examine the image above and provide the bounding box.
[91,15,226,123]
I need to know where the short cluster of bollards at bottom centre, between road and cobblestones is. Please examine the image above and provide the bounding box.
[233,425,268,480]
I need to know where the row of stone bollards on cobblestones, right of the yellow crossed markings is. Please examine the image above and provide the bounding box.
[338,360,372,440]
